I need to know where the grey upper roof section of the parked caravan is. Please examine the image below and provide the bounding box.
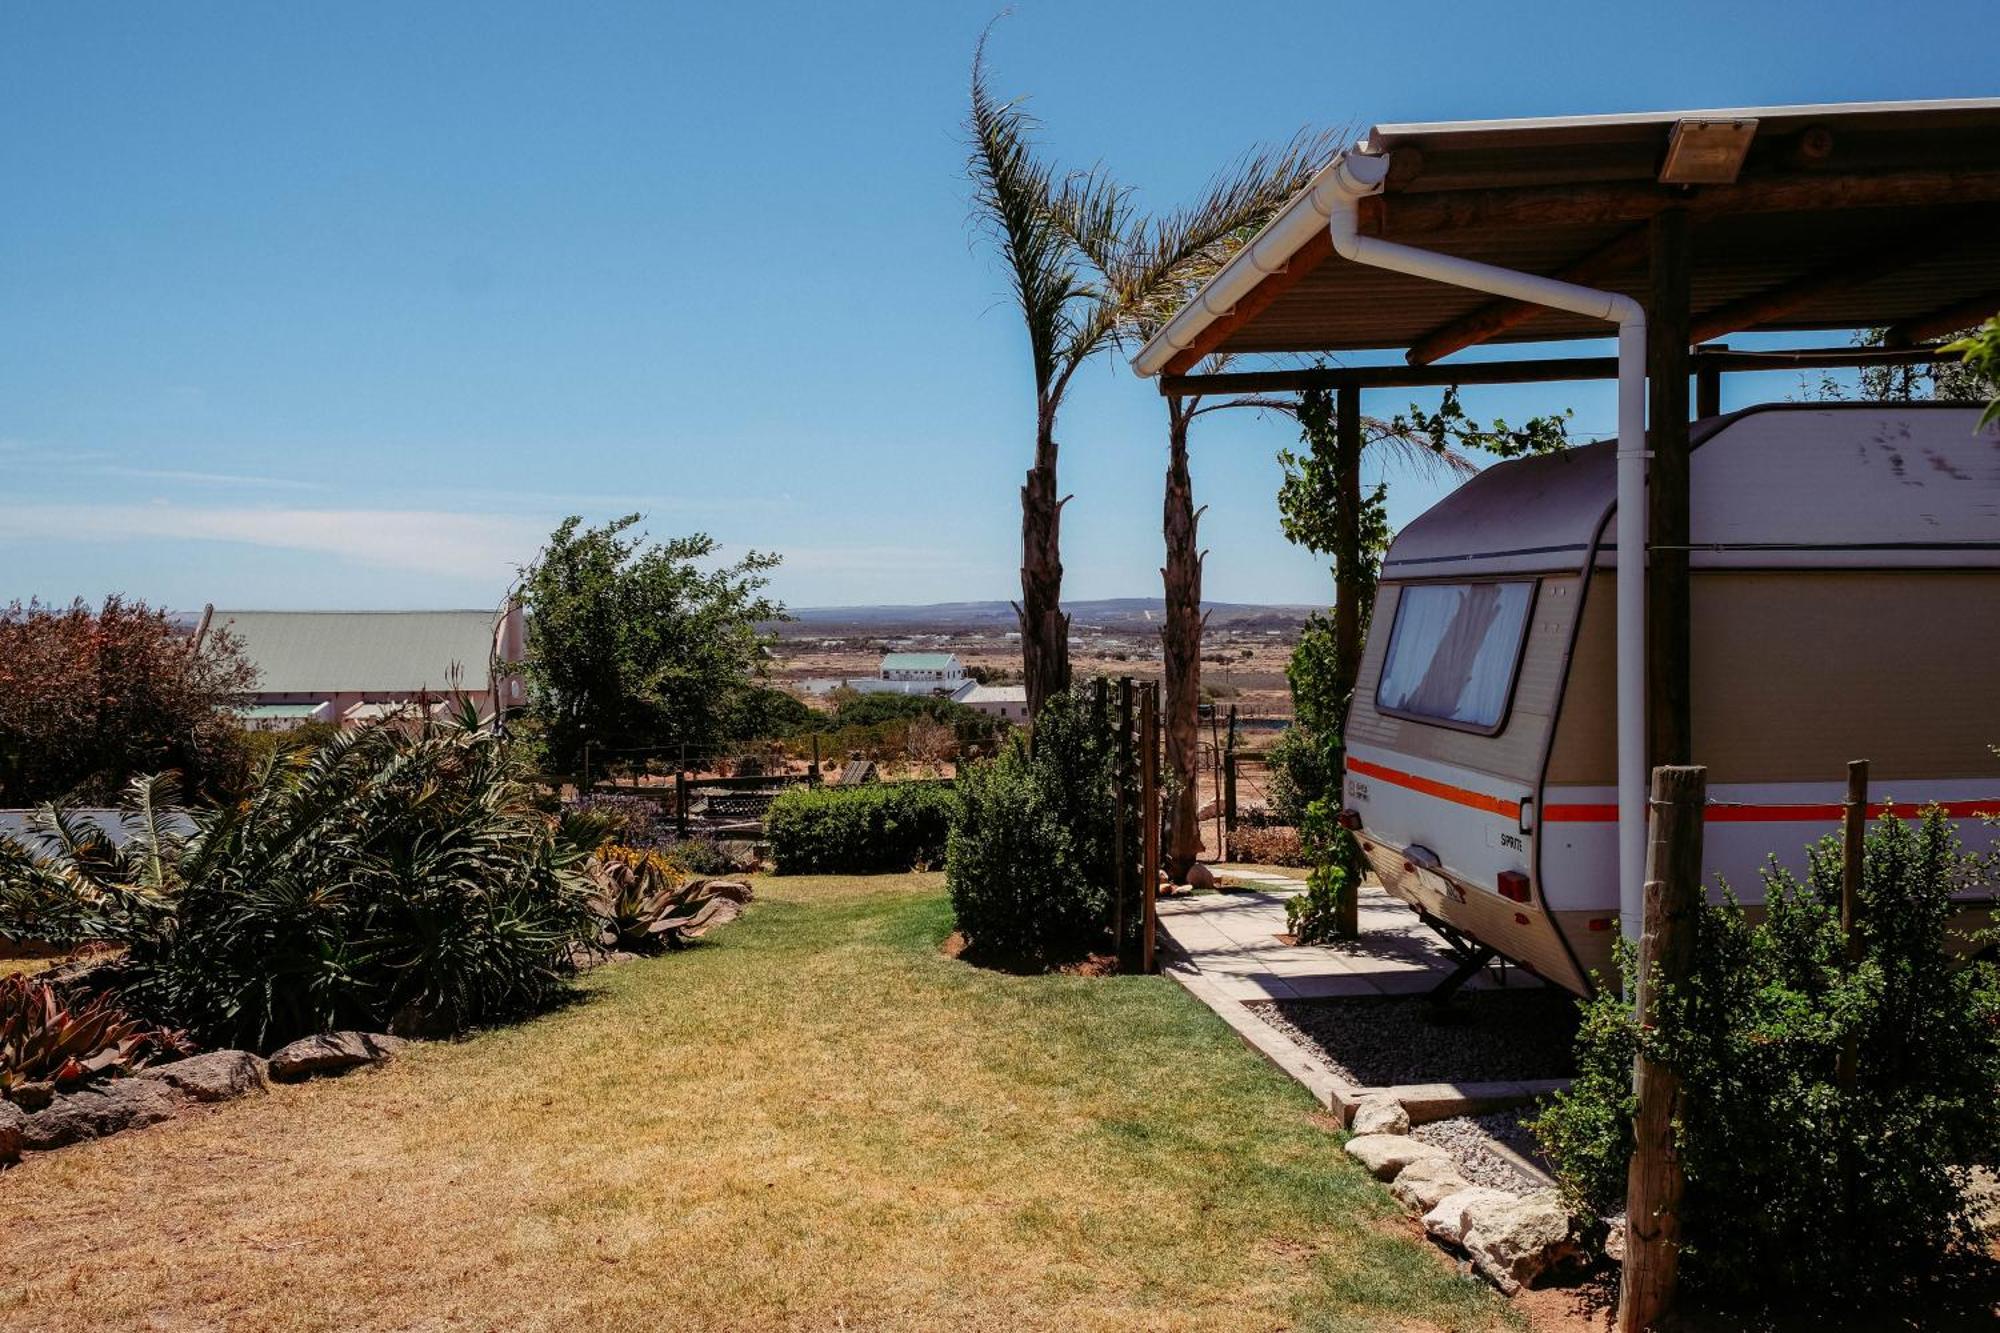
[1382,402,2000,580]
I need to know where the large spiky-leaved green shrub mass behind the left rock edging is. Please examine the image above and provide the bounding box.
[0,715,606,1049]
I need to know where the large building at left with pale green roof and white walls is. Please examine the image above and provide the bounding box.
[196,606,526,731]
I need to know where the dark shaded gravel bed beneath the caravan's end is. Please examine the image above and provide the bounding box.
[1250,987,1576,1087]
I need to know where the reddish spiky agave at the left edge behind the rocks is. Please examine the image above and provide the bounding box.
[0,964,192,1099]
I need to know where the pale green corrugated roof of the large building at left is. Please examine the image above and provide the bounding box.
[210,610,498,695]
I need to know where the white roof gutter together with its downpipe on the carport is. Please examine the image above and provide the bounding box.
[1132,146,1648,943]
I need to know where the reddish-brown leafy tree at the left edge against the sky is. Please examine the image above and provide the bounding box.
[0,596,256,805]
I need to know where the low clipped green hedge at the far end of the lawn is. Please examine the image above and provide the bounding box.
[764,783,958,875]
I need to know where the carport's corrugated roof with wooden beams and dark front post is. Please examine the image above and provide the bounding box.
[1134,100,2000,929]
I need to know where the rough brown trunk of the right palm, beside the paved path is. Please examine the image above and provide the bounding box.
[1160,398,1202,885]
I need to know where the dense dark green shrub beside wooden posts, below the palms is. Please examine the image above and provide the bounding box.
[946,693,1118,965]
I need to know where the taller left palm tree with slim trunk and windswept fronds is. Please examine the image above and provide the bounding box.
[966,28,1332,717]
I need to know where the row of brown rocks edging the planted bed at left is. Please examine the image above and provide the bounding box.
[0,1033,406,1165]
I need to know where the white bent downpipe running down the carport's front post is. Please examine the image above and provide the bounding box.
[1312,152,1648,943]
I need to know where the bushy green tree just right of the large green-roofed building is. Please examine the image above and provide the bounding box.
[522,514,784,771]
